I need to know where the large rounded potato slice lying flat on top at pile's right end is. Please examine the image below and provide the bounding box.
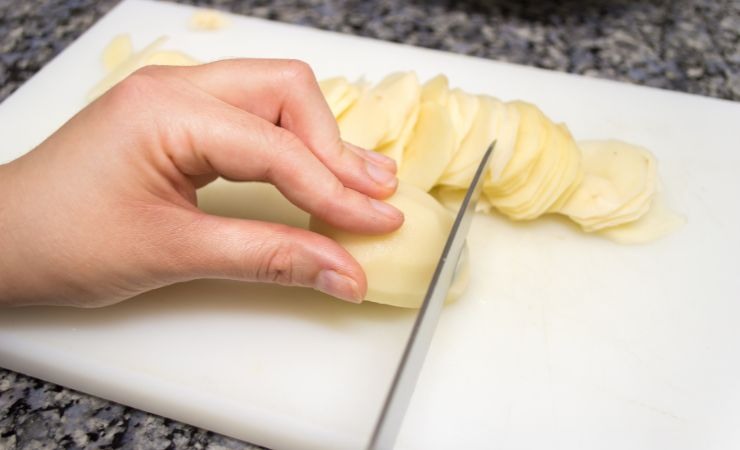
[558,140,657,231]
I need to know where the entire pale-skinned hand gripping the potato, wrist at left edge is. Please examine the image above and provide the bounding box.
[0,60,403,307]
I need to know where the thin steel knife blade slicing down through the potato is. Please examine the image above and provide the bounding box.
[367,141,496,450]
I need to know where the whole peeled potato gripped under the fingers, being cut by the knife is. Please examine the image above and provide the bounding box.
[310,183,467,308]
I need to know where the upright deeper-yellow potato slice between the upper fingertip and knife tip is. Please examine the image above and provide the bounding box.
[398,102,455,191]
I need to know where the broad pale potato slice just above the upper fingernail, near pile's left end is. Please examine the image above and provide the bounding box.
[338,72,421,150]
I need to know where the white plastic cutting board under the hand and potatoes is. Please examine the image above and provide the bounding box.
[0,0,740,449]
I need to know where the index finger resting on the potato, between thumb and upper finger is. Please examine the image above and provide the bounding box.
[141,76,403,233]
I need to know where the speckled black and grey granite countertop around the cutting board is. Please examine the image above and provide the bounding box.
[0,0,740,450]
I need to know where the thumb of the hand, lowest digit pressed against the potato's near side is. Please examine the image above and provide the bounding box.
[168,212,367,303]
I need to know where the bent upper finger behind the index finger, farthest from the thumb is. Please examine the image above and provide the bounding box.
[162,59,398,198]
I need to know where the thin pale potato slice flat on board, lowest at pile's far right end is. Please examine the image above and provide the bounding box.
[598,195,686,244]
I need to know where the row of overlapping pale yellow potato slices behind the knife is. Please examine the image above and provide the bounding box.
[319,72,680,242]
